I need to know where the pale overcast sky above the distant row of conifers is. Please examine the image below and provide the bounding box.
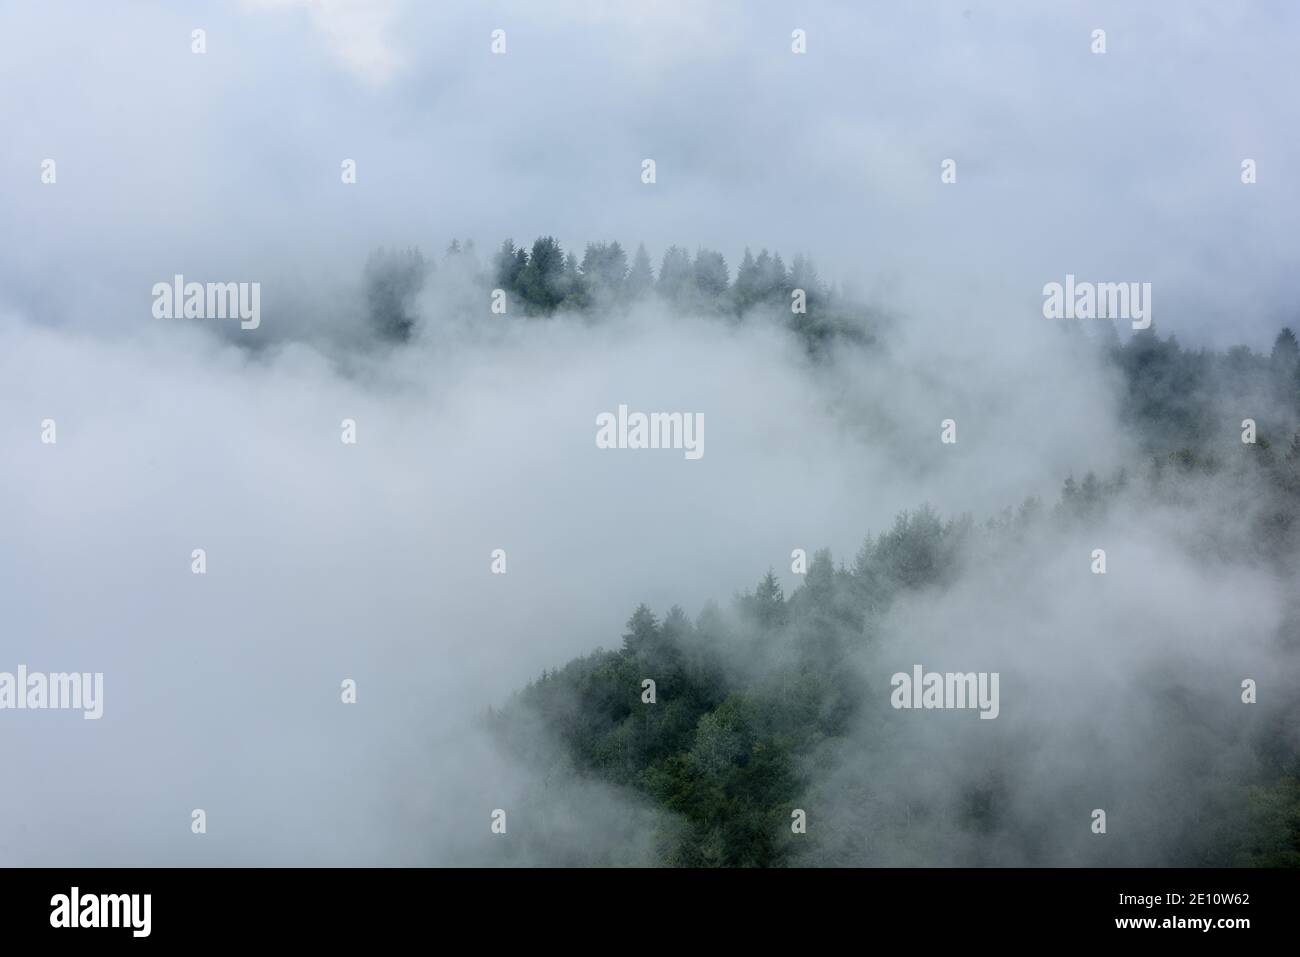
[0,0,1300,347]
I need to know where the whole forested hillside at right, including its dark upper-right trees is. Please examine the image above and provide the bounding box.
[489,321,1300,866]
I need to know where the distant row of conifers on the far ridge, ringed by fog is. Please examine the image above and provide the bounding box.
[364,237,879,354]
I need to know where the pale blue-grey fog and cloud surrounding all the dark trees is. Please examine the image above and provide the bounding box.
[0,1,1300,866]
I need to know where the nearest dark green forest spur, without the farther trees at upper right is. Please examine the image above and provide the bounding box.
[489,438,1300,866]
